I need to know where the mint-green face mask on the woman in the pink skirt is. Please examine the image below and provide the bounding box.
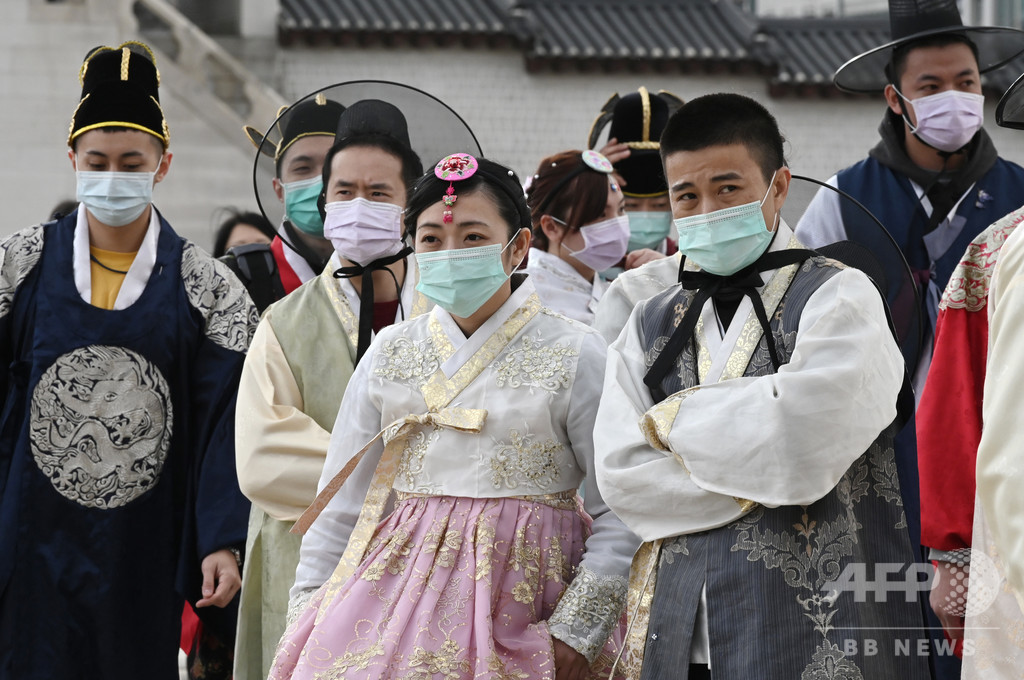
[416,229,521,318]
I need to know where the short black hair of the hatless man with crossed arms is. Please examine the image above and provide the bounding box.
[662,93,786,181]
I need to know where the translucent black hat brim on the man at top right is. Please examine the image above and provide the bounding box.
[833,26,1024,94]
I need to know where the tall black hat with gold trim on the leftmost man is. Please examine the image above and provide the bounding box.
[68,41,171,148]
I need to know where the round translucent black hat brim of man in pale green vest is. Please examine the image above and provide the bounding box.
[253,80,483,224]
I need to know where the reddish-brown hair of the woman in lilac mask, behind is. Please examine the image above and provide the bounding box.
[526,150,608,250]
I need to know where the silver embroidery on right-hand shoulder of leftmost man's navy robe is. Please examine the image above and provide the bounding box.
[181,241,259,352]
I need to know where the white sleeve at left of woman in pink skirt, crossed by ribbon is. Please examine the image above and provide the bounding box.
[290,343,384,598]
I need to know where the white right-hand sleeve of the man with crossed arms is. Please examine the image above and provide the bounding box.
[666,269,903,507]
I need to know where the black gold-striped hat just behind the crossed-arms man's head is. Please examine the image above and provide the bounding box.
[587,87,683,198]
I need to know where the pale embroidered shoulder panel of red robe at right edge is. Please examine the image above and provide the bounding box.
[939,209,1024,311]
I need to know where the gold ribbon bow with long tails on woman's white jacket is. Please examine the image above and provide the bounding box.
[292,408,487,622]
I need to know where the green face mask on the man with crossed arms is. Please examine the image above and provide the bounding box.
[673,174,775,277]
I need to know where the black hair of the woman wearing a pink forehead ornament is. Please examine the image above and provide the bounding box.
[406,158,530,239]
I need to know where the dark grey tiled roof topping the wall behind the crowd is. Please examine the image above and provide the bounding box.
[278,0,1024,96]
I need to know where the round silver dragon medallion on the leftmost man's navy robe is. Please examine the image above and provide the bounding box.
[29,345,173,509]
